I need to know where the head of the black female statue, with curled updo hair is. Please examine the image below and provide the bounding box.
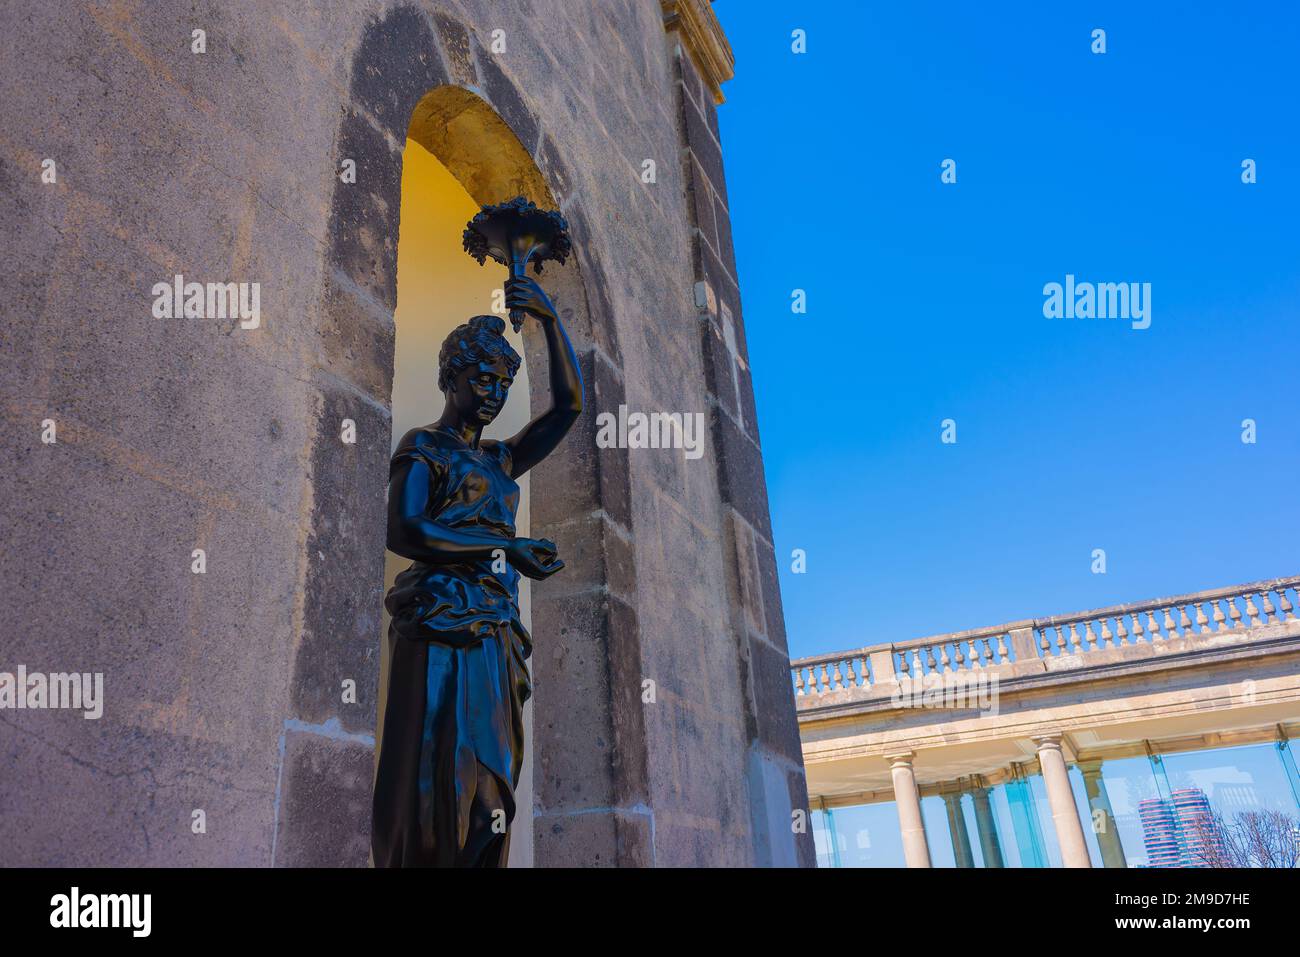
[438,316,520,425]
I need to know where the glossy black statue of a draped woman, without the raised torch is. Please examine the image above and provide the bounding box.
[372,276,582,867]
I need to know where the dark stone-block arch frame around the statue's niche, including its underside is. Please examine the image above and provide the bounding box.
[291,7,653,866]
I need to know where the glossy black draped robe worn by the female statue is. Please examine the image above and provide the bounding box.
[372,428,532,867]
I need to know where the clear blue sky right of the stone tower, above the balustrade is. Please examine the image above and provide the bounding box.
[715,0,1300,657]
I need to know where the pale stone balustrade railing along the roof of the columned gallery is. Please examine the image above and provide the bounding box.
[790,576,1300,698]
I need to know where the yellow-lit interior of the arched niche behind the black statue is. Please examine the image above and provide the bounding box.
[376,86,586,866]
